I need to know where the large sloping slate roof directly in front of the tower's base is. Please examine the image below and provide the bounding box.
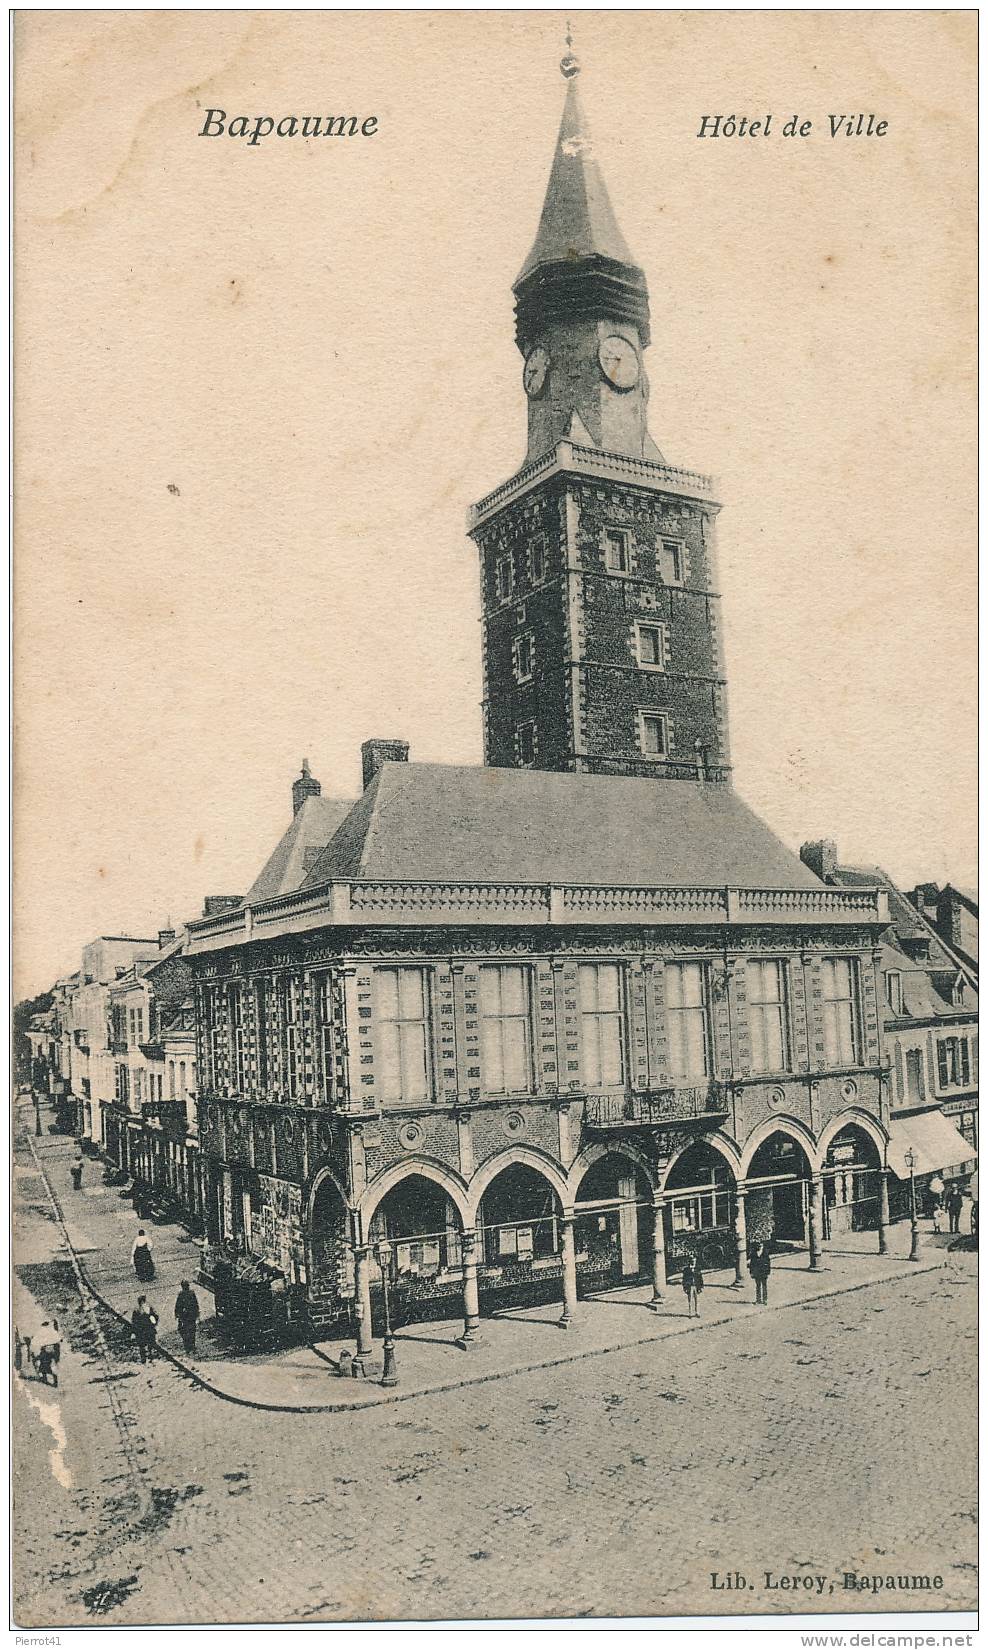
[303,762,821,889]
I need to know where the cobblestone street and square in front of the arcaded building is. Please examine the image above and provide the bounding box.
[13,1108,976,1627]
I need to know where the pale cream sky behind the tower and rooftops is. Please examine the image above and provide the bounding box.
[15,12,976,997]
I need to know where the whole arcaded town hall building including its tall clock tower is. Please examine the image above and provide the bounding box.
[185,56,889,1353]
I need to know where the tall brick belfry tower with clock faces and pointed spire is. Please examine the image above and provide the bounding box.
[468,41,729,780]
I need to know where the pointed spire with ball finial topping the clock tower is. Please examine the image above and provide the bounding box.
[515,51,635,289]
